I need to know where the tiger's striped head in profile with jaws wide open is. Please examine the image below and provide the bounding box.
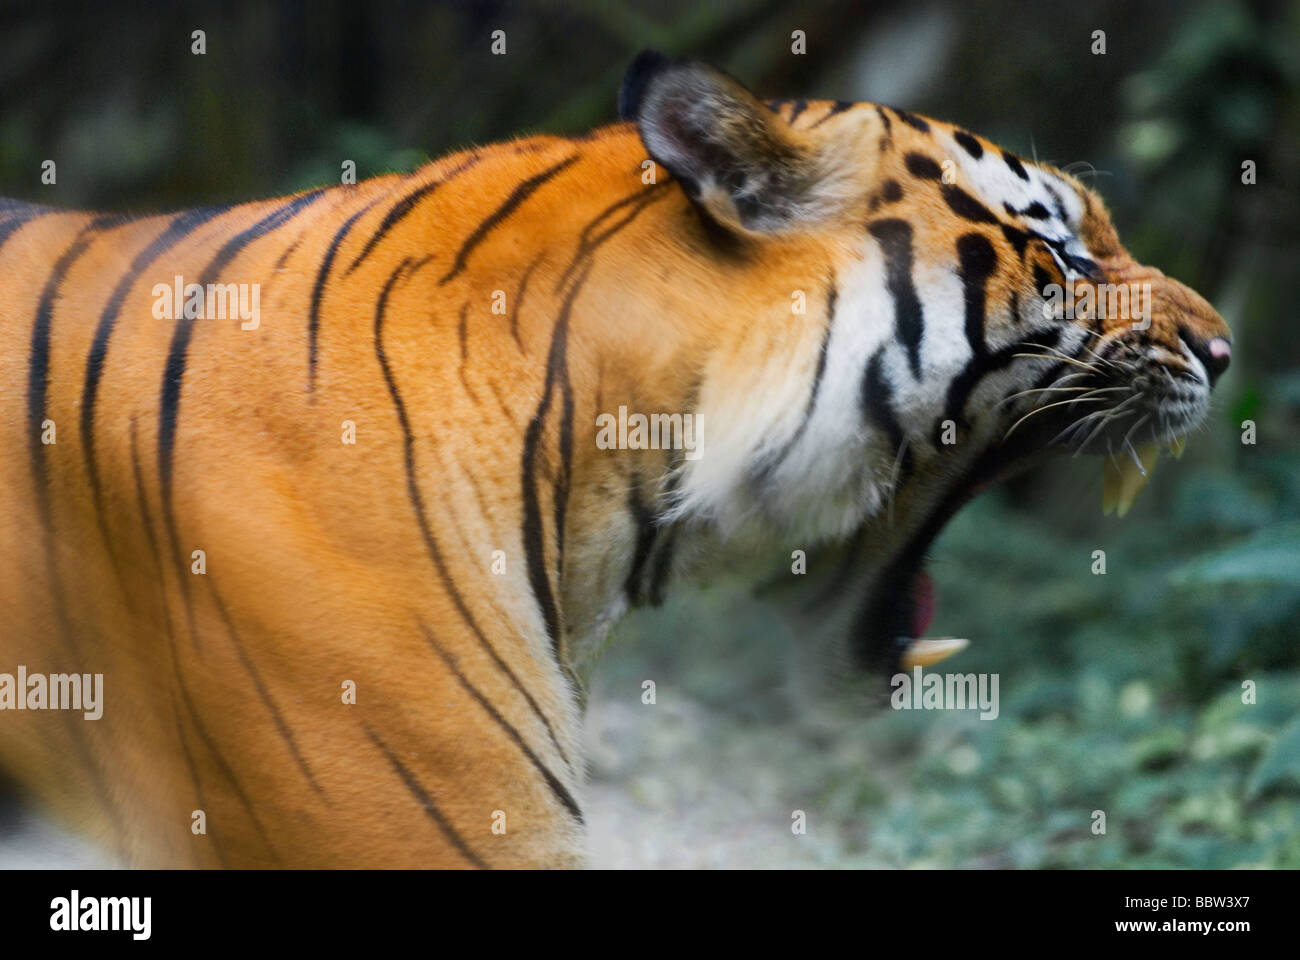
[608,52,1231,667]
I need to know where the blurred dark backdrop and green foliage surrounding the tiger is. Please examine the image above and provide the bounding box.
[0,0,1300,866]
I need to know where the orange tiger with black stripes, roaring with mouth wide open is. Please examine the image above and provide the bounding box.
[0,51,1231,869]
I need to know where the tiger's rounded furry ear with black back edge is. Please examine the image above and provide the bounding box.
[619,49,853,234]
